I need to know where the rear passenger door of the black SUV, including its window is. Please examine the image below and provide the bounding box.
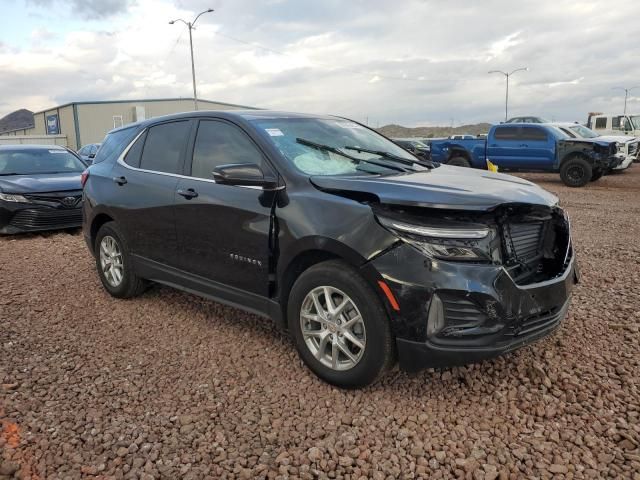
[112,120,193,266]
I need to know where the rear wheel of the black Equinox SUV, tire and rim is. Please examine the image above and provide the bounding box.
[94,222,147,298]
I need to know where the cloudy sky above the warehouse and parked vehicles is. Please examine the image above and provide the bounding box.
[0,0,640,126]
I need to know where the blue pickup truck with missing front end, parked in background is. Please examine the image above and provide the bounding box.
[429,123,622,187]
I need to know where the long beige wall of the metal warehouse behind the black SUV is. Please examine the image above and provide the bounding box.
[76,99,251,148]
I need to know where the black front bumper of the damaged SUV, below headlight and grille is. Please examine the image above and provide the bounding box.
[373,245,578,371]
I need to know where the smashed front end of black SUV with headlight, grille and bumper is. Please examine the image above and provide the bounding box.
[372,204,577,370]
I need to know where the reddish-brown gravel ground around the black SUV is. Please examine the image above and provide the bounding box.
[0,164,640,480]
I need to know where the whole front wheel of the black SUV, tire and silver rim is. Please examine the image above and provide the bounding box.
[287,260,395,388]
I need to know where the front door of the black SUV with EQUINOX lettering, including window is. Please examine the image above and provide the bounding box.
[176,119,275,296]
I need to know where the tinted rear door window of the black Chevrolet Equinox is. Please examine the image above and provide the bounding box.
[140,121,190,173]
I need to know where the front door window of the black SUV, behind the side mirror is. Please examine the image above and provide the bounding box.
[191,120,263,179]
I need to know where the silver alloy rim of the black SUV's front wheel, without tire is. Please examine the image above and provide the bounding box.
[300,286,367,371]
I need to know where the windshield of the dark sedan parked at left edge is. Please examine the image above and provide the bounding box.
[0,148,87,175]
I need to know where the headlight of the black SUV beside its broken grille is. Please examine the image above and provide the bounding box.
[377,217,501,263]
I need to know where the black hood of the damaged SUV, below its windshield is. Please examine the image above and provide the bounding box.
[310,165,558,210]
